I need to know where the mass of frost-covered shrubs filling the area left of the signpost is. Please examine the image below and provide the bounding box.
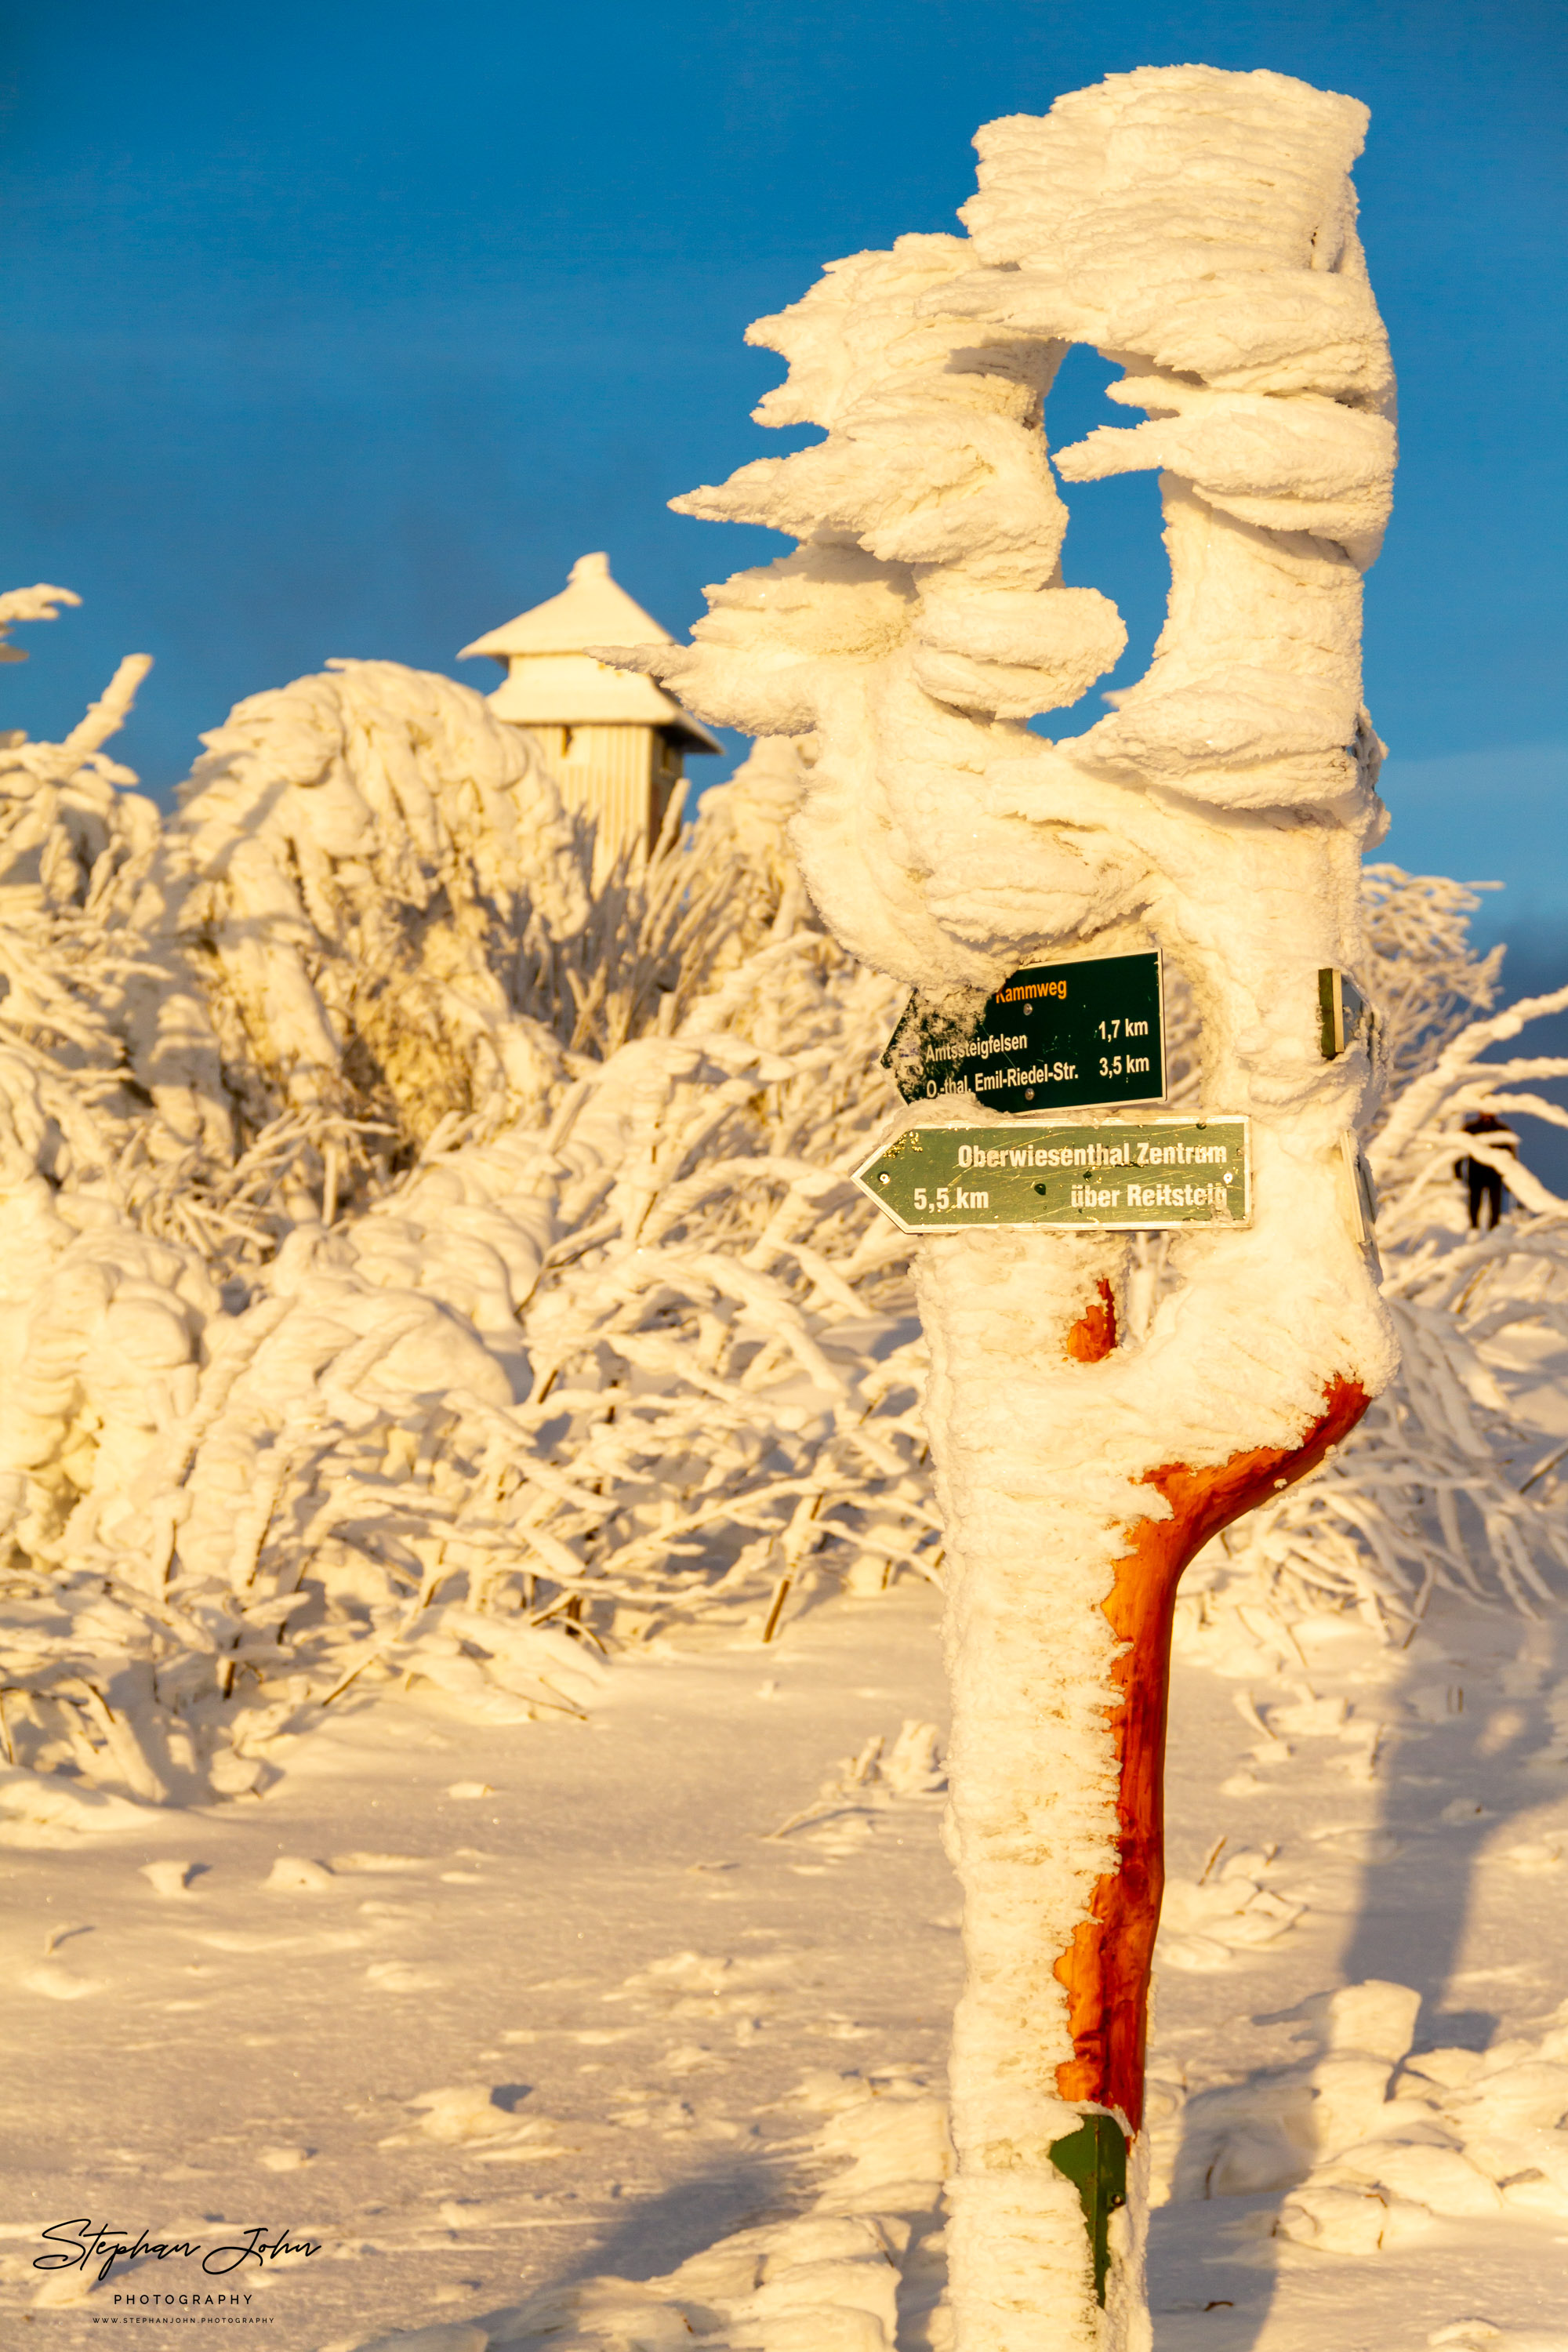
[0,626,935,1797]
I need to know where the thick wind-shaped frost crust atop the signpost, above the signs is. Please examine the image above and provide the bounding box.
[611,66,1394,983]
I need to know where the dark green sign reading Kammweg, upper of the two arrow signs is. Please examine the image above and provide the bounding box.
[881,950,1166,1115]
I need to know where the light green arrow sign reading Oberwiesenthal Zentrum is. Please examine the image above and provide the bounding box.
[855,1117,1250,1232]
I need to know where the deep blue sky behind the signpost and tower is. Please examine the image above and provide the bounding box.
[0,0,1568,967]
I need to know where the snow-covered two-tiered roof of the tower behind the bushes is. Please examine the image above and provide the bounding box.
[459,555,720,750]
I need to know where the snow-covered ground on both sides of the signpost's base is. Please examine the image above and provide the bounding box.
[2,1543,1568,2352]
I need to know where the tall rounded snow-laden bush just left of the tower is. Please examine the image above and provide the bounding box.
[179,661,588,1141]
